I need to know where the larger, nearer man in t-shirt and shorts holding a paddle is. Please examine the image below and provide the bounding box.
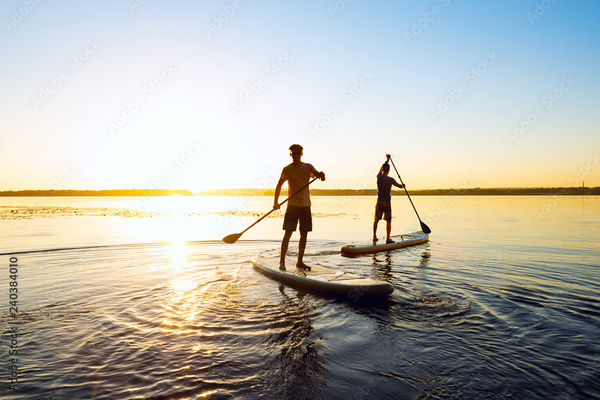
[273,144,325,271]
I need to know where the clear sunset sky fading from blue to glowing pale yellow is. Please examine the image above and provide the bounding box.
[0,0,600,191]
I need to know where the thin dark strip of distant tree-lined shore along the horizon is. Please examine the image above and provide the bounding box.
[0,187,600,197]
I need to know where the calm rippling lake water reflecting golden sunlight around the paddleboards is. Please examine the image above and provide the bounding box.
[0,196,600,400]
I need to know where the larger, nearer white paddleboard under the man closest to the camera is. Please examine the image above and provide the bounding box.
[252,257,394,297]
